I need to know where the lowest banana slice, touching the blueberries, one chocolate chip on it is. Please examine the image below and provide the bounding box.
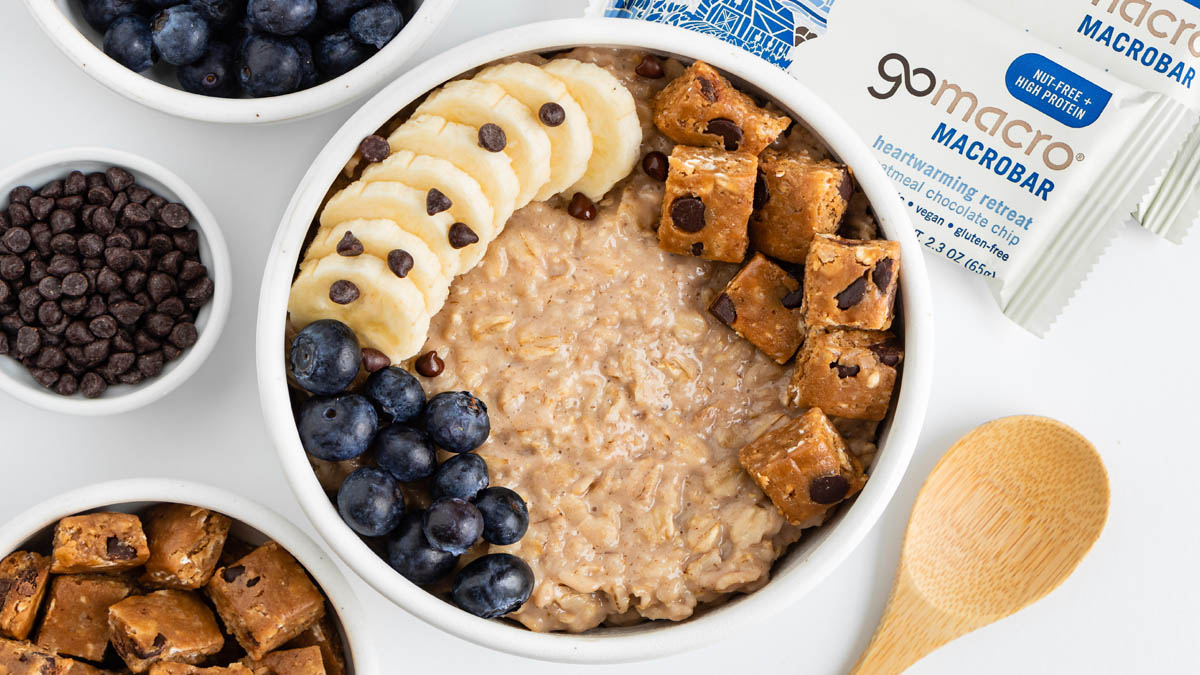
[288,253,430,363]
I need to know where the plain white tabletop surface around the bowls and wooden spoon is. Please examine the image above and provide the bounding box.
[0,0,1200,675]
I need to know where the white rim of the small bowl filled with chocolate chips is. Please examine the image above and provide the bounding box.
[0,145,233,416]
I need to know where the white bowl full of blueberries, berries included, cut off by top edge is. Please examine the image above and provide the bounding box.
[25,0,456,124]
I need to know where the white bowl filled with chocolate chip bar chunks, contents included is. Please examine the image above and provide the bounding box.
[0,478,378,675]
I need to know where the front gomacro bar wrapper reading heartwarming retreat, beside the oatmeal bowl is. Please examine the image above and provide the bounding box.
[589,0,1194,335]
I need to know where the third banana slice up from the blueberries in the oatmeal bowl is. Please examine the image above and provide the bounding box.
[320,181,487,279]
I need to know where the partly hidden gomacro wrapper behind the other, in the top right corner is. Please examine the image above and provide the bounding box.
[970,0,1200,243]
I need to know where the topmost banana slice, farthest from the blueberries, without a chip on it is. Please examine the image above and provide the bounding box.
[541,59,642,201]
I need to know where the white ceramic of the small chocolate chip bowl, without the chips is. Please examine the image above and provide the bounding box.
[0,148,233,416]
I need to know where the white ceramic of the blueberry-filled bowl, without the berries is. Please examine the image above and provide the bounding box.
[25,0,458,124]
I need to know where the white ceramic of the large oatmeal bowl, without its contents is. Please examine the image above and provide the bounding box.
[258,19,934,663]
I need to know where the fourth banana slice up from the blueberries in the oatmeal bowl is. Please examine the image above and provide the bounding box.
[359,150,498,244]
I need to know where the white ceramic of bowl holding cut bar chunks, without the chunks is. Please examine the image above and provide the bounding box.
[0,478,379,675]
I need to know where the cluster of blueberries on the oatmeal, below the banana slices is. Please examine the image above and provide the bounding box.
[288,319,534,619]
